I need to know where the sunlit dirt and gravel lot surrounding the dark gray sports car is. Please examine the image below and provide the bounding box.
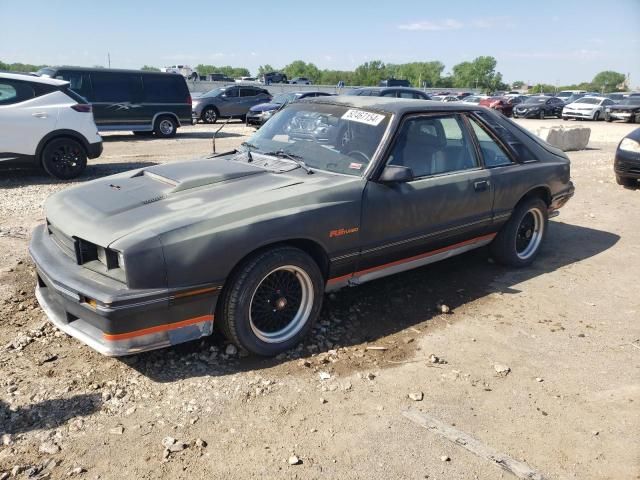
[0,120,640,480]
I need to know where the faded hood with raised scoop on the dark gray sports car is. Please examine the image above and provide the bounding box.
[45,155,360,247]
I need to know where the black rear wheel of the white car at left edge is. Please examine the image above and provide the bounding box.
[40,137,87,180]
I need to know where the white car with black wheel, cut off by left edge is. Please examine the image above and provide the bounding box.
[0,73,102,180]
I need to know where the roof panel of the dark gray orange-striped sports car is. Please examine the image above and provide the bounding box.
[301,95,478,115]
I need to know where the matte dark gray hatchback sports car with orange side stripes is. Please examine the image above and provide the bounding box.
[30,97,574,355]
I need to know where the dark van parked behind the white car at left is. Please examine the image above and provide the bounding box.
[38,67,192,137]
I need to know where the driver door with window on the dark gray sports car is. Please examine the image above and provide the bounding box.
[355,114,492,278]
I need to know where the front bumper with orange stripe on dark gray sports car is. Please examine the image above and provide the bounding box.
[29,226,219,356]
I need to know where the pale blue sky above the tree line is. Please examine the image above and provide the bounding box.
[0,0,640,86]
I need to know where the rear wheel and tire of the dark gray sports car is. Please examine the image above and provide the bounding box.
[491,197,549,268]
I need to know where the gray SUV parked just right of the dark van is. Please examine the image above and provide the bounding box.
[192,85,271,123]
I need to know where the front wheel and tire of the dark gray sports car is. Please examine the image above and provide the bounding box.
[216,246,324,356]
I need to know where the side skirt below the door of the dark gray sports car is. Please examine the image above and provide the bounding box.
[325,233,496,292]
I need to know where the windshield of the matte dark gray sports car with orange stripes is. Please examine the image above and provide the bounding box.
[243,103,391,176]
